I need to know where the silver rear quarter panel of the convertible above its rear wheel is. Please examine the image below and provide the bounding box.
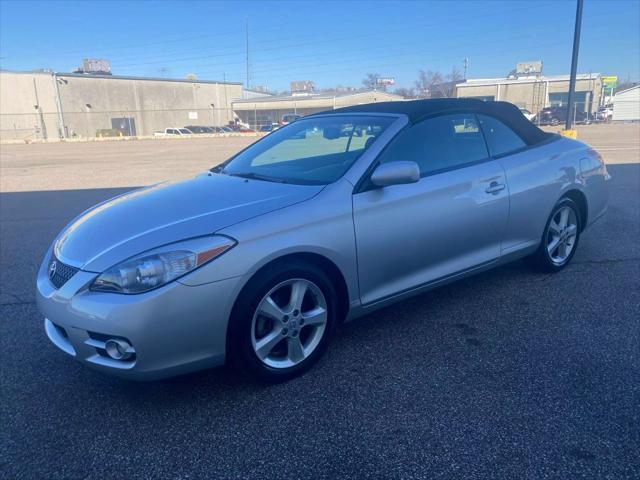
[500,138,588,256]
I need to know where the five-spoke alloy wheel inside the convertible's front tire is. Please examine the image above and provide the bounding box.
[251,278,328,369]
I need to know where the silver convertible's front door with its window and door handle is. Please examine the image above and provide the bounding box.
[353,114,509,304]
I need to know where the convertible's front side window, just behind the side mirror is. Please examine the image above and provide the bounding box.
[380,114,489,176]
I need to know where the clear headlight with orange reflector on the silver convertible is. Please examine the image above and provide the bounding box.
[90,235,236,294]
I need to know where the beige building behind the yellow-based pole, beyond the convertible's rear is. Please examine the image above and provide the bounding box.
[456,73,602,114]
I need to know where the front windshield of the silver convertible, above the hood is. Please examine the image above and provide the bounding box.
[216,115,395,185]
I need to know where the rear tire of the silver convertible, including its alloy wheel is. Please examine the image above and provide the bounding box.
[525,197,582,273]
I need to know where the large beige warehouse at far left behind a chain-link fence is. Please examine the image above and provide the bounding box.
[0,71,243,140]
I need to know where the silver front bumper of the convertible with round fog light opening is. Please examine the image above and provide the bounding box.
[36,253,240,380]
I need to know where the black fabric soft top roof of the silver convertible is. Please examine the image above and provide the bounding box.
[322,98,548,145]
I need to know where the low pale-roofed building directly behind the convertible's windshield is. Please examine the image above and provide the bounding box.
[233,90,404,128]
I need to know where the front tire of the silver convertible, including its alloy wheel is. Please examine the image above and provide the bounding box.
[227,260,338,383]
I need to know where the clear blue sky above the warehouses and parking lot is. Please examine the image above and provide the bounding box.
[0,0,640,90]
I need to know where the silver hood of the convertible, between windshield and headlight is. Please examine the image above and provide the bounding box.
[54,174,322,272]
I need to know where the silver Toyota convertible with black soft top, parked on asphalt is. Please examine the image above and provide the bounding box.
[37,99,610,381]
